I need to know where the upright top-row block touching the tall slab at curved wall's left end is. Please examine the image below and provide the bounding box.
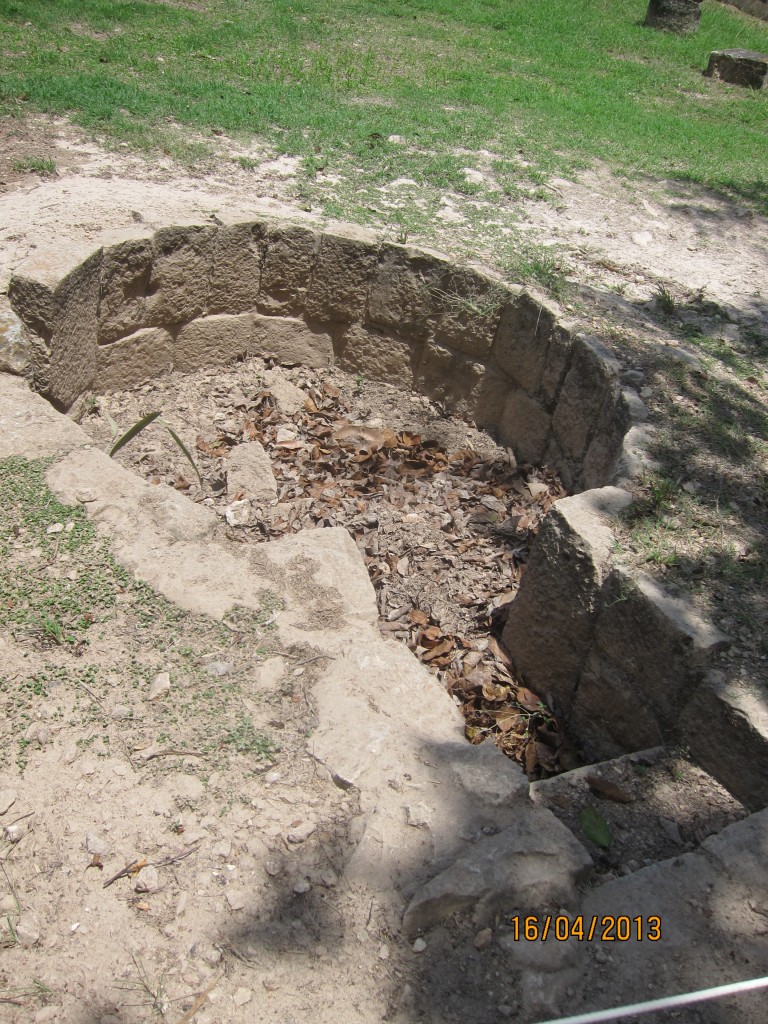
[98,239,152,344]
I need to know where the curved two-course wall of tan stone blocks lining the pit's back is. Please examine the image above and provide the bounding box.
[9,221,631,490]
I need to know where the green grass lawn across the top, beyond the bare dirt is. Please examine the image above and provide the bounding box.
[0,0,768,208]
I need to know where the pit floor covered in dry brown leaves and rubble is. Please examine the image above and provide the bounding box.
[80,358,581,778]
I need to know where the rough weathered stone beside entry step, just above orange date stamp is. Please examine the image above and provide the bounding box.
[402,807,593,935]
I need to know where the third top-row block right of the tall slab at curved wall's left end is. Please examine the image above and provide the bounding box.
[207,223,266,313]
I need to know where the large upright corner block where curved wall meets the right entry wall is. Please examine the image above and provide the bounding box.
[503,487,632,715]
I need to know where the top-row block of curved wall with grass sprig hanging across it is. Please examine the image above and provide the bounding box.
[434,267,510,359]
